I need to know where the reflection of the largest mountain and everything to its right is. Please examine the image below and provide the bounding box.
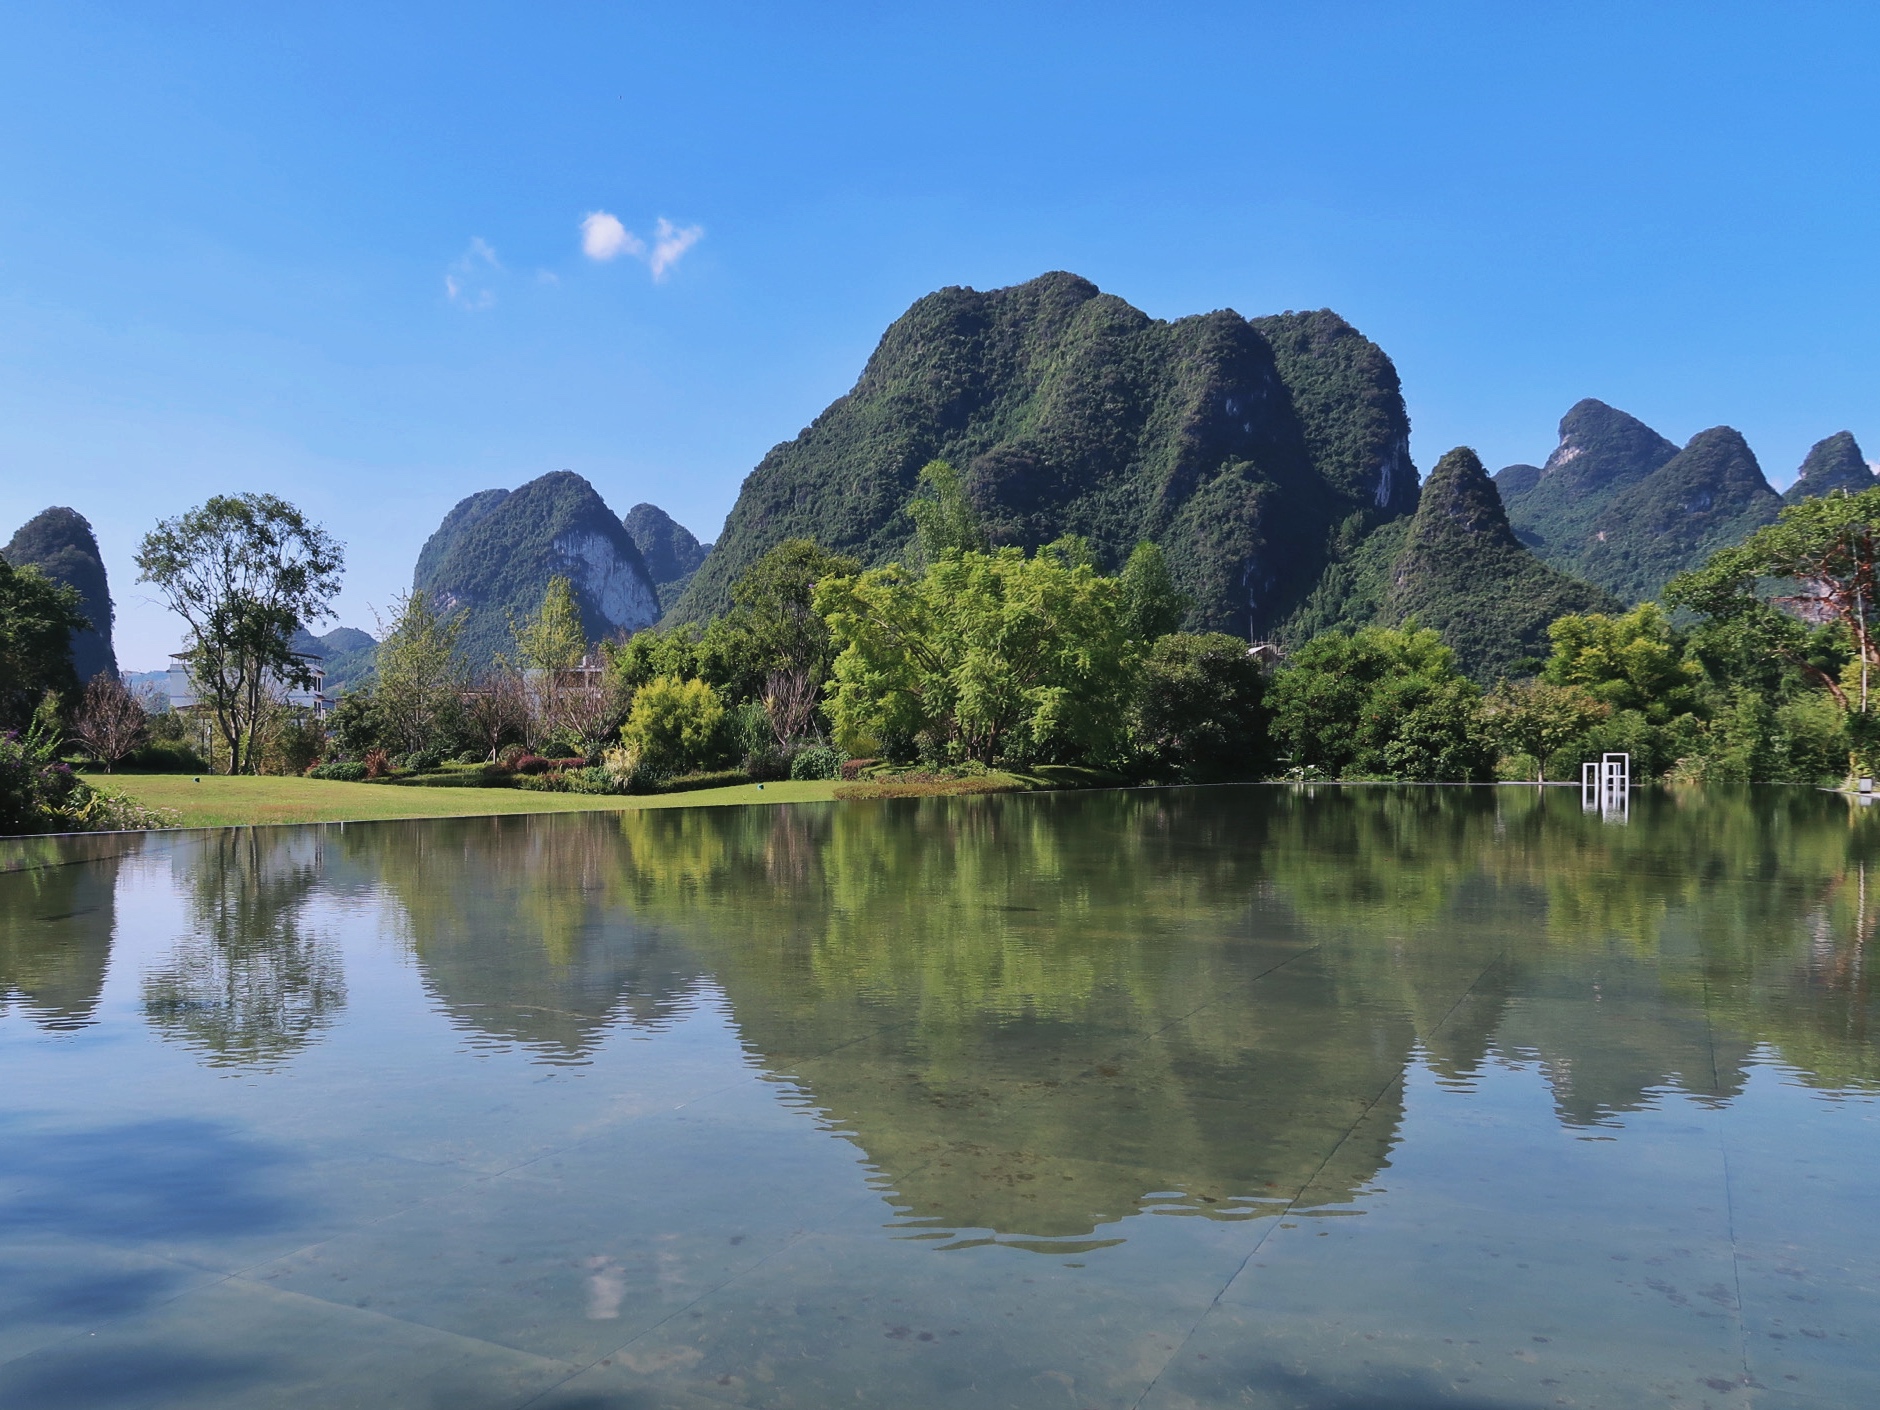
[594,790,1876,1235]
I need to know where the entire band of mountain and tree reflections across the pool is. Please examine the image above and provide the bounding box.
[40,788,1880,1239]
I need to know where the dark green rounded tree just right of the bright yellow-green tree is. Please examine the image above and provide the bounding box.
[1124,639,1269,782]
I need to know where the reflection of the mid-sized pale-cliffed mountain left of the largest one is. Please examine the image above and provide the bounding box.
[344,818,699,1062]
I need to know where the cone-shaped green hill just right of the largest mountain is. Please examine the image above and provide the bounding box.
[1284,446,1622,681]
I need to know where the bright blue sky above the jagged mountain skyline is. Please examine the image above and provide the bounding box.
[0,0,1880,669]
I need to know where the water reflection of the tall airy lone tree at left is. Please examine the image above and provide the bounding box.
[143,827,346,1066]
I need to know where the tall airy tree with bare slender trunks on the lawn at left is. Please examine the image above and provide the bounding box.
[137,494,344,773]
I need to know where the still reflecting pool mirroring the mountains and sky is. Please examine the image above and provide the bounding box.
[0,788,1880,1410]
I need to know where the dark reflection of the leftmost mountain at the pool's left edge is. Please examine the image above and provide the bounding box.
[0,838,141,1032]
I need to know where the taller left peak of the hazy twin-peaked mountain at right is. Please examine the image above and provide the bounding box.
[1495,397,1677,573]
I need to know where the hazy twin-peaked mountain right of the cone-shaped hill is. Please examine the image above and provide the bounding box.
[1495,399,1782,602]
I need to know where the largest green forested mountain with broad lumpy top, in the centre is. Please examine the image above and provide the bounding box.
[669,273,1418,635]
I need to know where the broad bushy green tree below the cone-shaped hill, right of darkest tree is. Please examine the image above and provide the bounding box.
[1267,622,1493,782]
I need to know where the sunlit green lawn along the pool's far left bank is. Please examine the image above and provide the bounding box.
[85,773,837,827]
